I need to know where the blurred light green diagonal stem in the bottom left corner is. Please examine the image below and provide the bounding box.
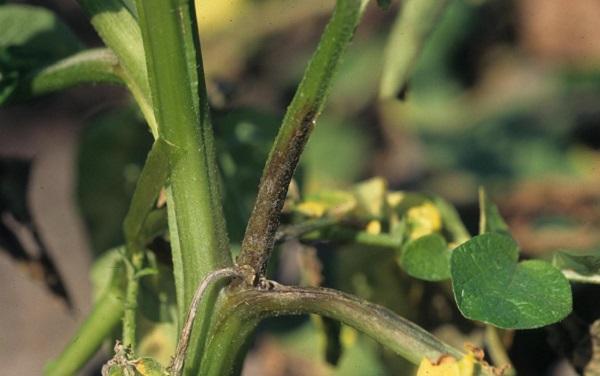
[44,287,124,376]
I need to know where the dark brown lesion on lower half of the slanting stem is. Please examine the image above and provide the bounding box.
[237,106,318,284]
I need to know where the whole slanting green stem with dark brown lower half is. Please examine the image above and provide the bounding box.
[238,0,367,282]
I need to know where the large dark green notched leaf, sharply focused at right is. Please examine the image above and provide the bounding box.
[450,233,572,329]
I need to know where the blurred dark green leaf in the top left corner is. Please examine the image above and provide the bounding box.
[0,4,83,104]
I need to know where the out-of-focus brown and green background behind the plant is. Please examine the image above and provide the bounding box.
[0,0,600,376]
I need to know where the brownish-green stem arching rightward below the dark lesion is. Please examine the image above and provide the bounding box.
[201,285,464,376]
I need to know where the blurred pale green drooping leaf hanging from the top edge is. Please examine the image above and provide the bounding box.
[379,0,450,99]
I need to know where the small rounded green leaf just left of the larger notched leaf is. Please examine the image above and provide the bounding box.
[400,234,451,281]
